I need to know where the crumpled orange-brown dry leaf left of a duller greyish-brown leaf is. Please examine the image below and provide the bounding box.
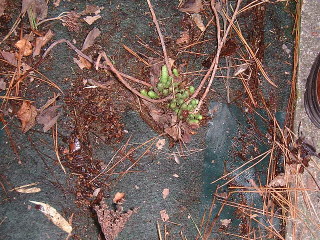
[17,101,37,133]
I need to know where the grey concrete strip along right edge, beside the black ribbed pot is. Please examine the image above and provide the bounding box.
[286,0,320,240]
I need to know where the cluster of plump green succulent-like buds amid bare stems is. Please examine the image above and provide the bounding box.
[140,65,202,124]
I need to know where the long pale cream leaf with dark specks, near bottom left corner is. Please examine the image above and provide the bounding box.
[30,201,72,233]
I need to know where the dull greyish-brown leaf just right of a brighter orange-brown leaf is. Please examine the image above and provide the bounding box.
[37,105,61,132]
